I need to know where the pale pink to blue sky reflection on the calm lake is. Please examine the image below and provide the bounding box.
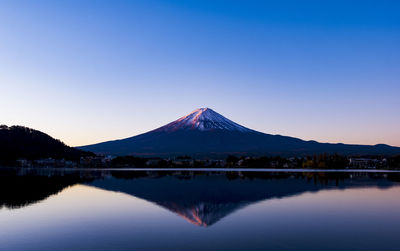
[0,178,400,250]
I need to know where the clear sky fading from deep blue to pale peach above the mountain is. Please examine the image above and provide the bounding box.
[0,0,400,146]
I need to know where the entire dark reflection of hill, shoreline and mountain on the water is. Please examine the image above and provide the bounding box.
[0,171,400,226]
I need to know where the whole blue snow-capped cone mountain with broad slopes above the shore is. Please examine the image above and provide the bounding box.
[79,108,400,158]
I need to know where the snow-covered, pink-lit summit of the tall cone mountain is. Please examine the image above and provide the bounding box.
[155,108,252,132]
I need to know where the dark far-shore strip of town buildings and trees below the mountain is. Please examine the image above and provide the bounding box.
[16,154,400,169]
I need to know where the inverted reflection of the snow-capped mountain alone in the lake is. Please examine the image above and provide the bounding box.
[91,173,400,226]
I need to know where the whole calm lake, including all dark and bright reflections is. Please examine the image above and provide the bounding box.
[0,169,400,250]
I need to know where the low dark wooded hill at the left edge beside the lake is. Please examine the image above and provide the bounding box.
[0,125,91,164]
